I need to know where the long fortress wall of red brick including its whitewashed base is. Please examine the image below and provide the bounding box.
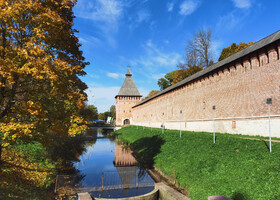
[132,41,280,137]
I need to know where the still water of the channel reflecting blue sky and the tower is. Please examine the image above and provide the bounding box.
[58,129,154,198]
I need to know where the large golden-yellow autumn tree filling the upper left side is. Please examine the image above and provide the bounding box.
[0,0,87,158]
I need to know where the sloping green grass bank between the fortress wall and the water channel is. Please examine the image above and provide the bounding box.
[116,126,280,200]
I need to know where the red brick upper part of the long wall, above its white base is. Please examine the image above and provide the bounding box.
[133,42,280,133]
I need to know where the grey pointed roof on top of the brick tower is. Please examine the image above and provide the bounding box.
[116,69,142,97]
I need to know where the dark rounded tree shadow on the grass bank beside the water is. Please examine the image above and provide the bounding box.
[131,136,164,169]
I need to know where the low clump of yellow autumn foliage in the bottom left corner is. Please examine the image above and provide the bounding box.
[0,148,55,200]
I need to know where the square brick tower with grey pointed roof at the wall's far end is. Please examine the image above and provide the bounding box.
[115,69,142,125]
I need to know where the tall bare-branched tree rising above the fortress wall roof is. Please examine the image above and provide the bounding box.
[186,29,213,68]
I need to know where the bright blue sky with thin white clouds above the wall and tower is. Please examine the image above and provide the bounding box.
[74,0,280,112]
